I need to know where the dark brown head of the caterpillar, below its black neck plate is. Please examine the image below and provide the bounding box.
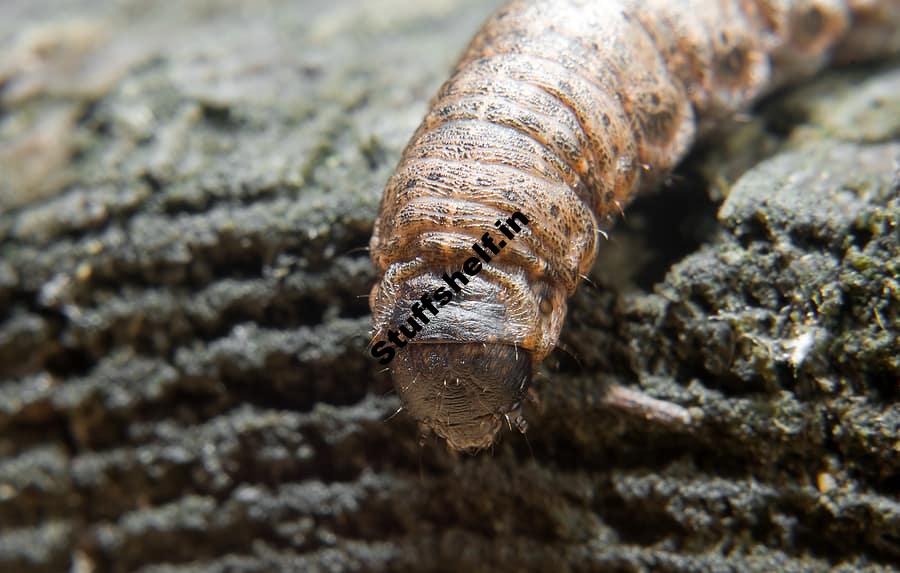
[393,342,532,451]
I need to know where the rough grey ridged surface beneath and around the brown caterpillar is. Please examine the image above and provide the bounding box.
[0,0,900,573]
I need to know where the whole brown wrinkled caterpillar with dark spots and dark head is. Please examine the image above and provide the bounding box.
[369,0,900,450]
